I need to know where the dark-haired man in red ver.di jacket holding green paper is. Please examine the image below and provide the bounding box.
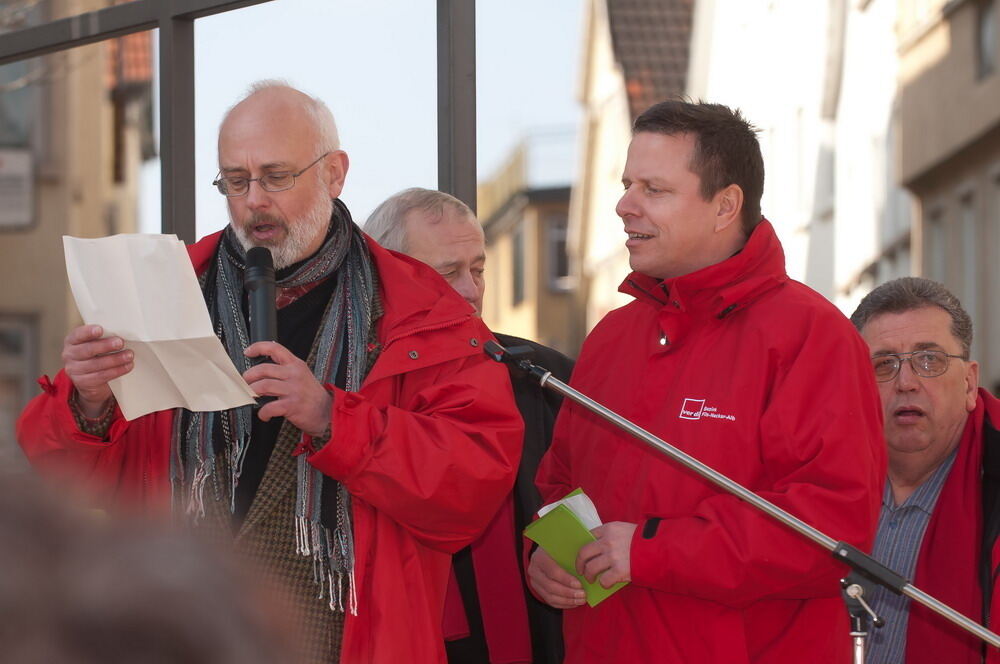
[529,101,885,664]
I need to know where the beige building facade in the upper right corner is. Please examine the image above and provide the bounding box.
[898,0,1000,393]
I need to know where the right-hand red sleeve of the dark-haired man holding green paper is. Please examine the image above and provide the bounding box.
[631,330,885,607]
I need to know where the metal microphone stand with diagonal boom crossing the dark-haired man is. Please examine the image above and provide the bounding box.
[483,341,1000,664]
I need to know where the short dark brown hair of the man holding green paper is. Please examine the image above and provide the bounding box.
[632,99,764,237]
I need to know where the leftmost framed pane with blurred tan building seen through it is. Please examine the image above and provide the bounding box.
[0,28,155,472]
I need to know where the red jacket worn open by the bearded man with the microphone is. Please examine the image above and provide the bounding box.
[18,234,523,664]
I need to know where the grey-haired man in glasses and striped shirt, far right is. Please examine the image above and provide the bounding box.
[851,277,1000,664]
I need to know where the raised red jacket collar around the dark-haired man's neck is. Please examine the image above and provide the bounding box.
[618,219,788,315]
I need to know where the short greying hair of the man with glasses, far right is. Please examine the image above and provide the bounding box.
[851,277,972,360]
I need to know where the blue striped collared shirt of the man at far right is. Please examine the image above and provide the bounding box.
[865,447,958,664]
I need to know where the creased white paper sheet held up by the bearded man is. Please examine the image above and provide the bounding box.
[63,234,256,420]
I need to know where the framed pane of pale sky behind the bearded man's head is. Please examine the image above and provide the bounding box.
[189,0,437,237]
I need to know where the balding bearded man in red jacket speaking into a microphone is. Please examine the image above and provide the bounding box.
[18,82,522,663]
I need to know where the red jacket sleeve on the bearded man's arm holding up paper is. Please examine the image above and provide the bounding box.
[16,371,170,508]
